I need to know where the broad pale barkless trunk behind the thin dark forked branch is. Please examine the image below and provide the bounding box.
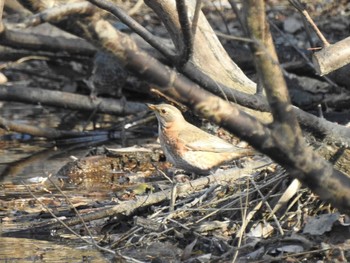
[145,0,256,94]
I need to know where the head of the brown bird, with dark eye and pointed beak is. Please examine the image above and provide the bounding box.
[148,104,184,128]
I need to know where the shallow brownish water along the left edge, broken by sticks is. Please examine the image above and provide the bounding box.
[0,103,119,262]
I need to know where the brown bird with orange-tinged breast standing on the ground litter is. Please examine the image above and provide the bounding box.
[148,104,254,173]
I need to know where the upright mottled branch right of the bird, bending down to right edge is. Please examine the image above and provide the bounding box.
[244,0,350,209]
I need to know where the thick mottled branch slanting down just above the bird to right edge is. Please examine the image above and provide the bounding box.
[84,17,350,210]
